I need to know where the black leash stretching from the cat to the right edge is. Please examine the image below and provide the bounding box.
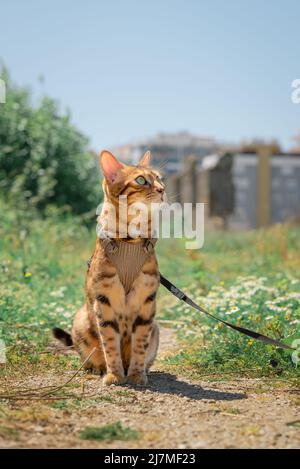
[160,273,295,350]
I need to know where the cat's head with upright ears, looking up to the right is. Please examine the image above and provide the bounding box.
[100,150,166,205]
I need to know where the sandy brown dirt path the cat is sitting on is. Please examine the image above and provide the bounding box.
[0,329,300,448]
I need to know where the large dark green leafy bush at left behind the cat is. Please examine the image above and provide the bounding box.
[0,69,101,214]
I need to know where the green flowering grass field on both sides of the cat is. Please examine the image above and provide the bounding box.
[0,200,300,379]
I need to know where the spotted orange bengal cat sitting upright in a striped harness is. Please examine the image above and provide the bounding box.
[54,151,165,385]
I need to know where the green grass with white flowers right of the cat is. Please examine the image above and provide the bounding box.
[161,225,300,379]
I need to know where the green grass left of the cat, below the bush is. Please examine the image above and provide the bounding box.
[0,197,94,352]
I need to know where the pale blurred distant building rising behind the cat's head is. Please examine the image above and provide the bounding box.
[113,132,219,175]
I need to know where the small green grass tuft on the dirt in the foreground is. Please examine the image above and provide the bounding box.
[80,422,139,441]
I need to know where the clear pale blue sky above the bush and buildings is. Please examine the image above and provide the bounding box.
[0,0,300,150]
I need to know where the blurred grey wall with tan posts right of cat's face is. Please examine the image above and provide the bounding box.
[167,147,300,229]
